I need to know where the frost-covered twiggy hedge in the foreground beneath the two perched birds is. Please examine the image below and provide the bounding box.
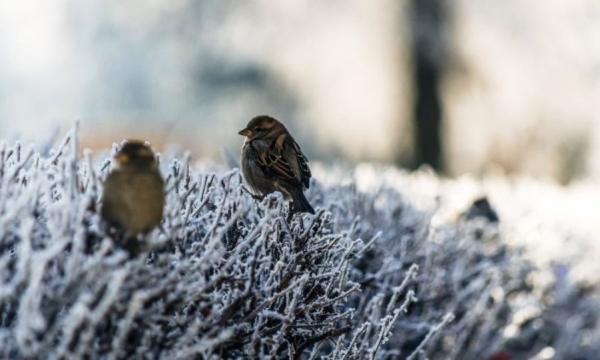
[0,132,597,359]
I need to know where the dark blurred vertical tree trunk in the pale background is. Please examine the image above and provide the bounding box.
[408,0,447,172]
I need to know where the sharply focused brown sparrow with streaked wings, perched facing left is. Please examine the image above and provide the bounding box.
[238,115,315,214]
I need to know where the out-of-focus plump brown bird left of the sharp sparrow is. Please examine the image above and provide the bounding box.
[101,140,165,251]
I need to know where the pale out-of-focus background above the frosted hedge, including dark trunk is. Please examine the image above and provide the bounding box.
[0,0,600,184]
